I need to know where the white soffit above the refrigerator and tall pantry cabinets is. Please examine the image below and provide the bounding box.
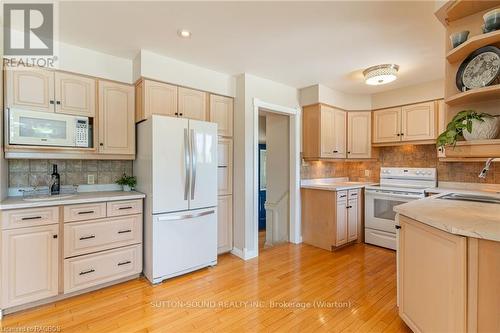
[138,50,235,96]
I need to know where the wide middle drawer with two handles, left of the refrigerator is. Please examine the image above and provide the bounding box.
[64,215,142,258]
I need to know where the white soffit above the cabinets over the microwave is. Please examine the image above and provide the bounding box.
[58,43,133,83]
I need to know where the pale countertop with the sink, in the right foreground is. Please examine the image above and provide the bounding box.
[394,189,500,242]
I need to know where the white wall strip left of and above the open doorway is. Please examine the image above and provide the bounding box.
[233,74,299,256]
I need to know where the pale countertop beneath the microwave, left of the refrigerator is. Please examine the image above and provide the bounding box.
[0,191,145,210]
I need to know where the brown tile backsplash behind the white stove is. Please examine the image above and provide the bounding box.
[300,145,500,184]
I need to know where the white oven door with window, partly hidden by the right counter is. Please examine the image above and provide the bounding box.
[365,190,423,233]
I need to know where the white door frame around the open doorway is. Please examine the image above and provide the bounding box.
[251,98,302,257]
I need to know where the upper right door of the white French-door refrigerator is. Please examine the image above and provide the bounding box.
[189,120,217,209]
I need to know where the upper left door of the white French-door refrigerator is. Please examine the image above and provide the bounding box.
[152,115,190,214]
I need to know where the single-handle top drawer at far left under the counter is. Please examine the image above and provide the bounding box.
[0,207,59,229]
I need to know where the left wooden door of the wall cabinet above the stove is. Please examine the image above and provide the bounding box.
[373,107,401,143]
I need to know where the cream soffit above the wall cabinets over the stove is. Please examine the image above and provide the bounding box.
[372,79,444,110]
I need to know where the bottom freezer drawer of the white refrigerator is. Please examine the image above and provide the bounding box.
[152,208,217,283]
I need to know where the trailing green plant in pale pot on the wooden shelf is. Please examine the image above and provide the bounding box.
[436,110,499,147]
